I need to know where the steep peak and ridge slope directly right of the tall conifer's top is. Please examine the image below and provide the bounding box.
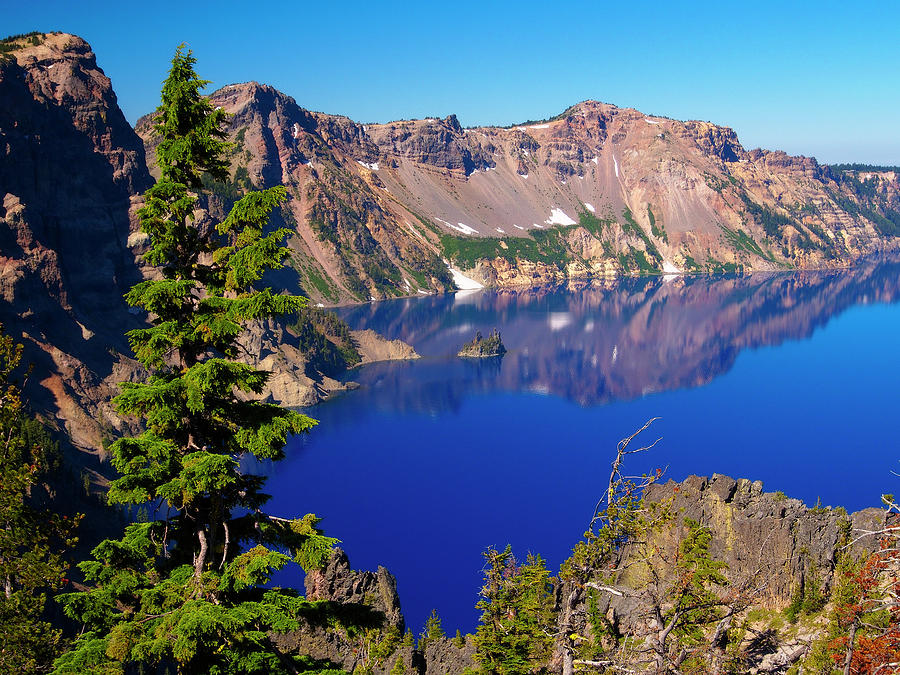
[137,83,460,303]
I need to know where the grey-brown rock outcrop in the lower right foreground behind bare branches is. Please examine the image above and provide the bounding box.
[550,475,886,673]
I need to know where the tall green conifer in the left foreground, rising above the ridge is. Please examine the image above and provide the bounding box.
[56,45,335,674]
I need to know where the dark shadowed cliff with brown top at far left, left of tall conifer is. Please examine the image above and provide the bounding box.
[0,34,151,449]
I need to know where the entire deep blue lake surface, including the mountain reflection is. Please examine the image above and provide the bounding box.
[256,262,900,634]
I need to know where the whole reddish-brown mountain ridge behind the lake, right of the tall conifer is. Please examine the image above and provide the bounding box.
[174,83,900,302]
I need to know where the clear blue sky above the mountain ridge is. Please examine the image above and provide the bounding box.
[7,0,900,164]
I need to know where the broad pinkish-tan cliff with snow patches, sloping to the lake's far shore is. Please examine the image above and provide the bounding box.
[368,101,900,285]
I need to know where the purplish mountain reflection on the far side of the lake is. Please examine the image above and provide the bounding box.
[338,262,900,412]
